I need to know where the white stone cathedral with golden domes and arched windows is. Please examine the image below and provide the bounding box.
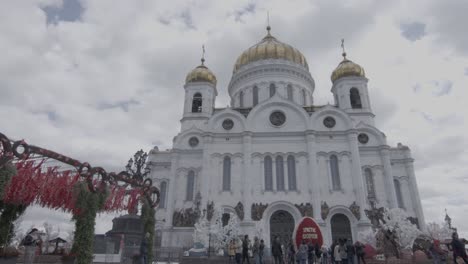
[149,27,425,248]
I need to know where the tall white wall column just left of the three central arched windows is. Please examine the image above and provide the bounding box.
[241,132,254,221]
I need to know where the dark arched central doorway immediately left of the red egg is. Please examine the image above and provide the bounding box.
[270,210,294,247]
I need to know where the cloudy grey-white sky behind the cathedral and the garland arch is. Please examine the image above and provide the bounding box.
[0,0,468,236]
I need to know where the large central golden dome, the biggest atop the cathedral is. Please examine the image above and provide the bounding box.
[233,27,309,72]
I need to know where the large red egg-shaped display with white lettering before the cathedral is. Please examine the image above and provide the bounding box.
[293,217,323,248]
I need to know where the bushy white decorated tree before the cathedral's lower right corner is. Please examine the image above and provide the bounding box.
[382,208,423,249]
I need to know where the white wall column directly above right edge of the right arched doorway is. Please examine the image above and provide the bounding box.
[348,131,369,222]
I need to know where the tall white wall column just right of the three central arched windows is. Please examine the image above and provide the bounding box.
[304,131,323,223]
